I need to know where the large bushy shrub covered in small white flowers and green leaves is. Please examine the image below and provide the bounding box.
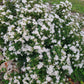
[0,0,84,84]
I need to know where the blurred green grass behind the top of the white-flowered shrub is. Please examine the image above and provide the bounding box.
[0,0,84,14]
